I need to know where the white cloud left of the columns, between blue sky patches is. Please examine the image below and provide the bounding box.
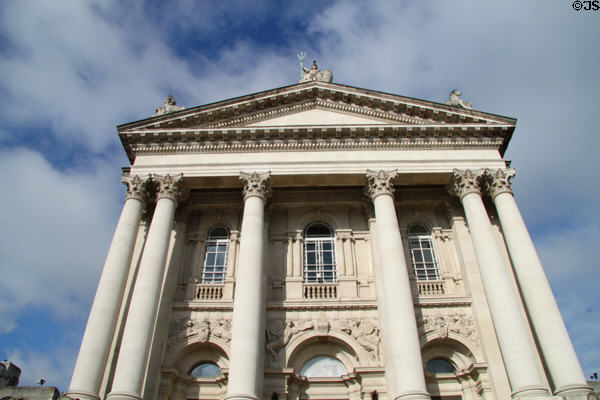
[0,149,120,333]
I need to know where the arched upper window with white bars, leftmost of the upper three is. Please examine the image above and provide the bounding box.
[201,226,229,283]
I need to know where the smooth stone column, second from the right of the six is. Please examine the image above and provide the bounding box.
[453,170,552,399]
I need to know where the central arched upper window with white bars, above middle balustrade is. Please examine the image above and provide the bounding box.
[304,222,337,283]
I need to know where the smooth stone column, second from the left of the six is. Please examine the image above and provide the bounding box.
[106,175,183,400]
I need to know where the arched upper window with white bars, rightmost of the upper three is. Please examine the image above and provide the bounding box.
[408,223,440,281]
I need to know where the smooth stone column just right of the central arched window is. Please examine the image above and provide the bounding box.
[366,171,430,400]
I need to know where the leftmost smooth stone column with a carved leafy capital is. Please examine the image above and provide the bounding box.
[68,175,149,400]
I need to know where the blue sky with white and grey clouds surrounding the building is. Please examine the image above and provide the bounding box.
[0,0,600,391]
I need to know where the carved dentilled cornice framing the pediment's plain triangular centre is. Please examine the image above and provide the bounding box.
[118,82,516,161]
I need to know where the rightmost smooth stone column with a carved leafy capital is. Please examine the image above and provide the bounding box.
[485,169,591,399]
